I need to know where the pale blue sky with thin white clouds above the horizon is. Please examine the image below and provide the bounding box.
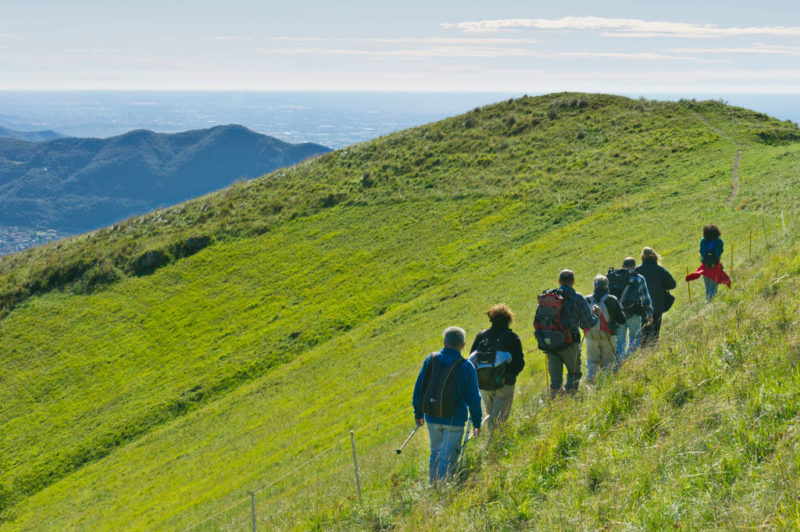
[0,0,800,94]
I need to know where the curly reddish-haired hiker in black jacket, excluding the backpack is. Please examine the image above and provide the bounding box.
[469,303,525,429]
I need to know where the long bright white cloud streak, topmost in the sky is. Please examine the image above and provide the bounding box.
[441,17,800,38]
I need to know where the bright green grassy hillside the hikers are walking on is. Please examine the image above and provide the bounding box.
[0,94,800,530]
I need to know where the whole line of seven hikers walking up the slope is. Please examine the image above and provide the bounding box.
[410,224,730,485]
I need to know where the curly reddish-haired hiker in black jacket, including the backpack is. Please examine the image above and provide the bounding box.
[469,303,525,430]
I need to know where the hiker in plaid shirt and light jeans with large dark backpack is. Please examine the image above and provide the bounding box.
[606,257,653,365]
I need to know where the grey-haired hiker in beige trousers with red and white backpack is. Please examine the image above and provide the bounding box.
[584,274,626,382]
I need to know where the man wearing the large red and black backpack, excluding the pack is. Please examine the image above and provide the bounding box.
[545,270,600,397]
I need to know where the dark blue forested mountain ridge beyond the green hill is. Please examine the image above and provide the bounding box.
[0,125,331,232]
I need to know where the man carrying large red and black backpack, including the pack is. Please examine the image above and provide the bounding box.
[533,270,600,397]
